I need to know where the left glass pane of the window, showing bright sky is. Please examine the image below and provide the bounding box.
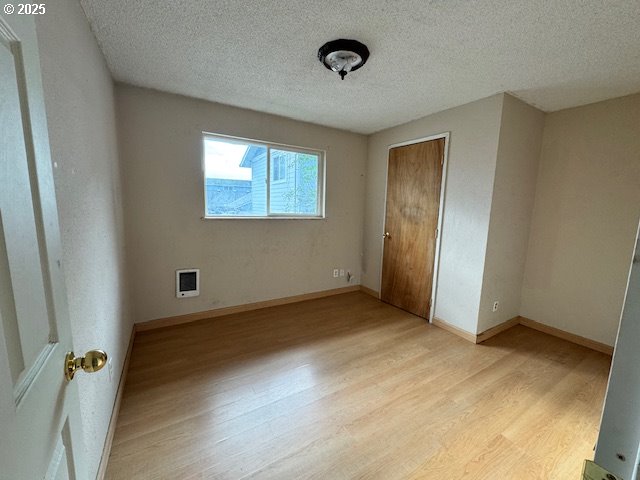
[204,137,267,216]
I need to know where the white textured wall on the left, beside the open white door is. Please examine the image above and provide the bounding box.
[36,0,132,476]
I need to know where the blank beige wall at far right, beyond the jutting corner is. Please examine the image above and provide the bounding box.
[521,95,640,345]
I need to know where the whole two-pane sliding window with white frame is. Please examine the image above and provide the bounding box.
[203,134,324,218]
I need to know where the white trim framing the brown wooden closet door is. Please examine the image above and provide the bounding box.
[378,132,451,323]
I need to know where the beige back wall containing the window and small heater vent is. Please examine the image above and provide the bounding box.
[116,85,367,322]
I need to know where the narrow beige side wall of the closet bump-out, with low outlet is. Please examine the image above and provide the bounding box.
[477,95,544,333]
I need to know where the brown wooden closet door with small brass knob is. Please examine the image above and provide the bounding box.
[380,138,445,318]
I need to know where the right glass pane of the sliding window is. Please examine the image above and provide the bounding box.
[269,148,319,215]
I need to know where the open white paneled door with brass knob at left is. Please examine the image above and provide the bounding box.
[0,14,86,480]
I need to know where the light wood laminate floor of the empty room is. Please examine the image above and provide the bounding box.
[107,292,610,480]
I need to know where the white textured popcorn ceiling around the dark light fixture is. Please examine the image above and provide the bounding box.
[81,0,640,133]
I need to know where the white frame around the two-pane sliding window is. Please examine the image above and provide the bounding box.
[200,131,327,220]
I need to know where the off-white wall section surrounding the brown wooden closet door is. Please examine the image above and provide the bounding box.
[362,95,504,333]
